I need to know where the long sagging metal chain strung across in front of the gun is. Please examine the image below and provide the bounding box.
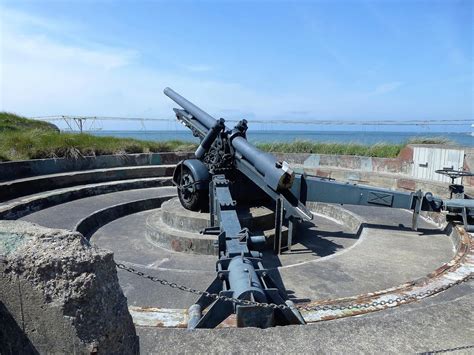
[115,263,474,311]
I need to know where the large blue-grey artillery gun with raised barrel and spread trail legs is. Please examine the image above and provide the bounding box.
[164,88,474,328]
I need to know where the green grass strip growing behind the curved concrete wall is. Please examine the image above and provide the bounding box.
[0,112,450,161]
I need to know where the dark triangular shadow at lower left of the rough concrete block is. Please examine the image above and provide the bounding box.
[0,301,39,355]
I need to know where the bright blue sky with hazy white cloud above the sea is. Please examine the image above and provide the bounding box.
[0,0,474,129]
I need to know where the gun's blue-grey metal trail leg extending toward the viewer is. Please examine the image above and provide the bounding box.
[188,175,304,328]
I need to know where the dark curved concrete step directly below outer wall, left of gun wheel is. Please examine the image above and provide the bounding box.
[0,165,174,202]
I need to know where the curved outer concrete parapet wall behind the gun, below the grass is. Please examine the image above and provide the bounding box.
[0,145,474,199]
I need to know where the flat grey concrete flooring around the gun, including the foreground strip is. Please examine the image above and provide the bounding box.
[16,188,474,353]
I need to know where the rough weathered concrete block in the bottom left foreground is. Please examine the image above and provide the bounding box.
[0,221,138,354]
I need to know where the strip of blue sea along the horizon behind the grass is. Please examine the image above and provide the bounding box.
[88,130,474,147]
